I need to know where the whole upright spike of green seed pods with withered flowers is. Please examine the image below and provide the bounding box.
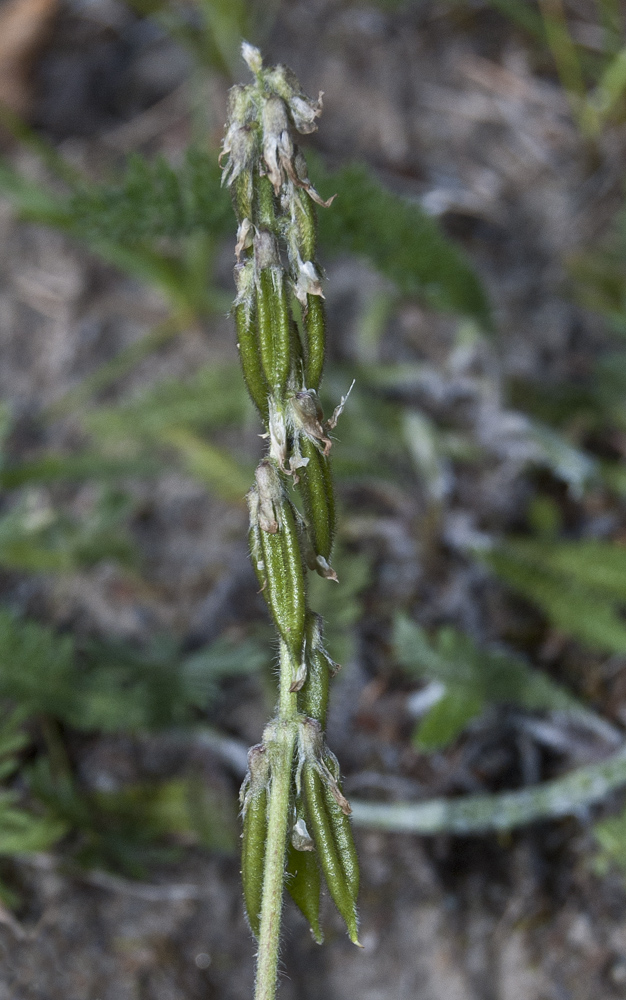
[222,43,358,942]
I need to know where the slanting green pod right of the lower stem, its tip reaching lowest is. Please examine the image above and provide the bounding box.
[302,761,359,944]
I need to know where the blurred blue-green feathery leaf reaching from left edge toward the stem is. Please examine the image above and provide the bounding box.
[0,611,267,733]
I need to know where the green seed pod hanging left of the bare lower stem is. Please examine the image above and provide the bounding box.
[241,743,270,938]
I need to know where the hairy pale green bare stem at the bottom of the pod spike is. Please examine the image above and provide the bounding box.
[254,642,297,1000]
